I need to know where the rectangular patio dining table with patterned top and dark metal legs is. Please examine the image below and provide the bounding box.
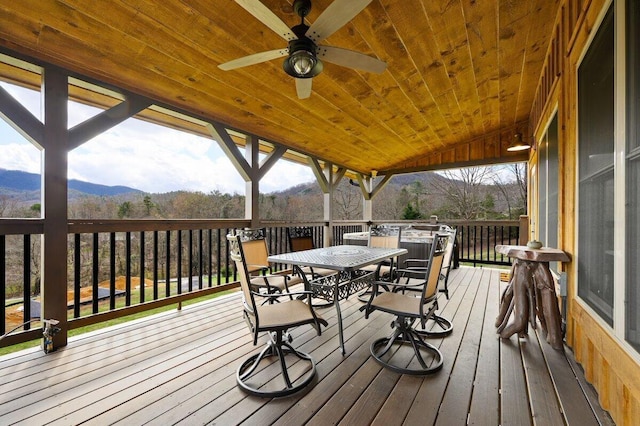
[268,245,407,355]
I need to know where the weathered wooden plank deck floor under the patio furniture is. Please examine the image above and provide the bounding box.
[0,267,610,426]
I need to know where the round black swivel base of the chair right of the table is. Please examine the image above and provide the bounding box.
[371,318,442,375]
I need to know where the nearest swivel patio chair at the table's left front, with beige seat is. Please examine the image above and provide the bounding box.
[227,235,327,398]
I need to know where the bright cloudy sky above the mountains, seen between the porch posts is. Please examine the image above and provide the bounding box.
[0,82,315,194]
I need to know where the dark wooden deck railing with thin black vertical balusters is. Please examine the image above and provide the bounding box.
[0,219,520,347]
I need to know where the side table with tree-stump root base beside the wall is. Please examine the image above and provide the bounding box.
[495,245,570,350]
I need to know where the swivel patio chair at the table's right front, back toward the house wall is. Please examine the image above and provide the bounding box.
[365,234,452,375]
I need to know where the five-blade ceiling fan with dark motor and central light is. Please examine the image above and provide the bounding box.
[218,0,387,99]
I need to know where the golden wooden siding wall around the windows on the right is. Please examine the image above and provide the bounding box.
[529,0,640,425]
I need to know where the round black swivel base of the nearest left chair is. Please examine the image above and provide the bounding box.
[236,331,316,398]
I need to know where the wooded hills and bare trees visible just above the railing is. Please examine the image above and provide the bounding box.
[0,163,527,222]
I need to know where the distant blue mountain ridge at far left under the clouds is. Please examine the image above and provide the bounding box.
[0,169,143,197]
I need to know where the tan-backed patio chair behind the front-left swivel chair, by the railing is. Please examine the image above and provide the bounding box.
[235,228,302,300]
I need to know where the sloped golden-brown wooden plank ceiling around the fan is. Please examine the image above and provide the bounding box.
[0,0,559,174]
